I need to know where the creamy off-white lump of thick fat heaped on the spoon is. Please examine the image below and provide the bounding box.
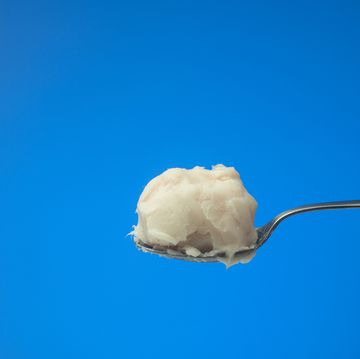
[131,165,257,266]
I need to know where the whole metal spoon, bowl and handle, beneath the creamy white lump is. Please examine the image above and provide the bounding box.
[135,200,360,262]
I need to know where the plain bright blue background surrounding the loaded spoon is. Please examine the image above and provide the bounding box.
[0,0,360,359]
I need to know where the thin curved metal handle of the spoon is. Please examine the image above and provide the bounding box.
[257,200,360,247]
